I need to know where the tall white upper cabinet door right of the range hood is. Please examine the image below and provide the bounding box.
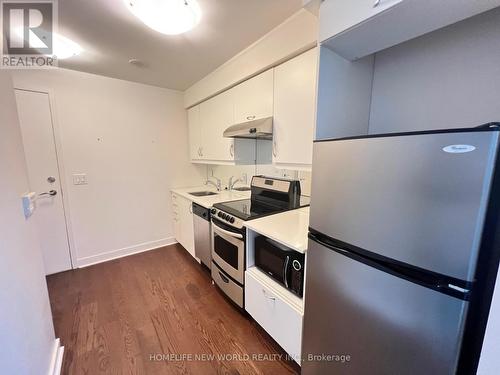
[273,48,318,165]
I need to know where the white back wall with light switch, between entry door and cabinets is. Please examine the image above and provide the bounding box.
[14,69,206,266]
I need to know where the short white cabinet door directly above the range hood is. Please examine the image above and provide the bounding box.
[233,69,273,124]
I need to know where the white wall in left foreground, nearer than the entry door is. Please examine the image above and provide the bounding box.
[0,71,55,375]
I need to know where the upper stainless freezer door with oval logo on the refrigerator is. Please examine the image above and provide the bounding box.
[310,132,498,281]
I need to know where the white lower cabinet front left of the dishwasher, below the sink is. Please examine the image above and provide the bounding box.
[172,193,195,257]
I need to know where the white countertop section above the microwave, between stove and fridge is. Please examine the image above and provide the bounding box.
[245,207,309,253]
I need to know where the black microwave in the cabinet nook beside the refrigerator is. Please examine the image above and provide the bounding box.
[255,236,305,297]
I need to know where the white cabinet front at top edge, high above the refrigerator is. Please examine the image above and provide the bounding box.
[319,0,403,42]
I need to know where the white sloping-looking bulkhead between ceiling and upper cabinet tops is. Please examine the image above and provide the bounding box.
[184,9,318,108]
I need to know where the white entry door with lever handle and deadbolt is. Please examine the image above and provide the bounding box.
[16,89,72,275]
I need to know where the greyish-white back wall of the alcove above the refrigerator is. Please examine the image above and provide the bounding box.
[369,9,500,133]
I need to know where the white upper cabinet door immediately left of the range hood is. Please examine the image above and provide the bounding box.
[200,90,234,161]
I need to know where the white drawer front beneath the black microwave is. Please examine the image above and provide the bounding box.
[245,267,304,365]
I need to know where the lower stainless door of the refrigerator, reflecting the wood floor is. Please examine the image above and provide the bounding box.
[302,240,468,375]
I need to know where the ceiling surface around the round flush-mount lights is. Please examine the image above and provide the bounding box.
[58,0,302,90]
